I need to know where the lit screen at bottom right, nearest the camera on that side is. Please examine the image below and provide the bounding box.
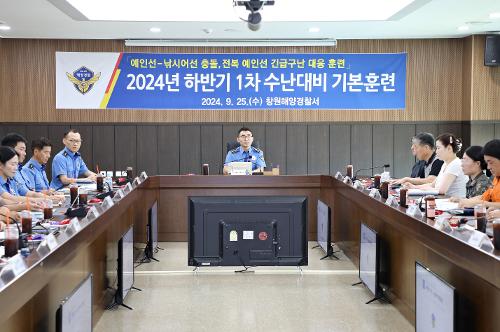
[415,262,457,332]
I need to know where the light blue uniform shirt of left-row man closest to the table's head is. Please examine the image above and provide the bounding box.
[50,147,89,190]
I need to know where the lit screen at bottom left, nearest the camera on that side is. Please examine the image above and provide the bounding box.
[56,274,92,332]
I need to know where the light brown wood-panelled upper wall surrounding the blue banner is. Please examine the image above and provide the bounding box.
[0,37,500,123]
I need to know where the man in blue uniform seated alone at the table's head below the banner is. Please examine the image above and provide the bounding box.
[224,127,266,174]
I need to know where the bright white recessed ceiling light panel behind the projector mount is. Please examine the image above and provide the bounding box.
[67,0,421,22]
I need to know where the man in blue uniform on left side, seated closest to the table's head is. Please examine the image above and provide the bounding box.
[50,129,96,190]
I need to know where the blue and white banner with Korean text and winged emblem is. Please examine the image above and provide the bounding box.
[56,52,406,110]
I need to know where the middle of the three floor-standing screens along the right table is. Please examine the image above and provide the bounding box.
[359,223,380,298]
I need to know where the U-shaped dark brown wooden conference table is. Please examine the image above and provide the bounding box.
[0,175,500,331]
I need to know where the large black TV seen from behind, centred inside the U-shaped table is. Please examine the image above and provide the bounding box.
[188,196,307,266]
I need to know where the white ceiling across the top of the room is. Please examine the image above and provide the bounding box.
[0,0,500,39]
